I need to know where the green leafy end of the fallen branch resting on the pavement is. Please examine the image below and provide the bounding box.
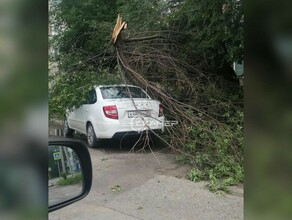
[185,105,244,191]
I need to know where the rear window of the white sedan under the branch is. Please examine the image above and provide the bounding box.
[100,86,148,99]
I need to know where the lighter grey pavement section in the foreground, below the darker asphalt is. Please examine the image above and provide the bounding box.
[49,175,243,220]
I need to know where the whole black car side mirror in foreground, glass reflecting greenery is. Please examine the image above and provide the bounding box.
[48,138,92,212]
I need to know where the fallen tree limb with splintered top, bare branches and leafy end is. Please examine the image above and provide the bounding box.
[112,16,243,190]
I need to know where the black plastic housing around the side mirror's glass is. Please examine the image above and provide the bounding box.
[48,137,92,212]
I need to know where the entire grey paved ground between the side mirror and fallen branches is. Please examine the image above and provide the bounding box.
[49,137,243,220]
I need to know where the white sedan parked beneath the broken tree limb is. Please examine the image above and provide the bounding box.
[64,85,164,147]
